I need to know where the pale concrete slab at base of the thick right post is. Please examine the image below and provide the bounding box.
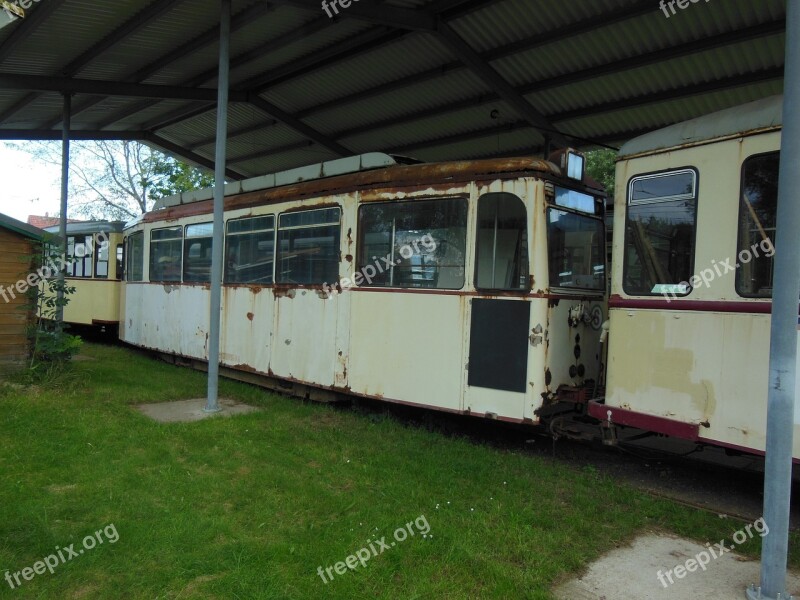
[553,534,800,600]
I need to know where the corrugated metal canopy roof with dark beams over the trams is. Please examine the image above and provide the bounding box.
[0,0,786,179]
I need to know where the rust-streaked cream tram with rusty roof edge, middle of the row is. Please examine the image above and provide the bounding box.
[120,152,606,423]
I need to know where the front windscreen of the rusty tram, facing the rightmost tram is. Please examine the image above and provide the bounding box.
[547,208,605,290]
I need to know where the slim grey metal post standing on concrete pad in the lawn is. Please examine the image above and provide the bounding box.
[203,0,231,412]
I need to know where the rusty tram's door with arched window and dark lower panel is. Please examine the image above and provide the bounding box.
[464,192,531,419]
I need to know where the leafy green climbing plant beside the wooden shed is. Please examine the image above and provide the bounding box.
[22,236,83,381]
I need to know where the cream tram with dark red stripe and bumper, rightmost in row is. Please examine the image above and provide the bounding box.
[589,97,800,458]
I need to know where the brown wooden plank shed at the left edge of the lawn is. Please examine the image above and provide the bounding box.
[0,214,44,372]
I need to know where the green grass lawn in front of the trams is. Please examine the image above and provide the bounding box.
[0,345,798,599]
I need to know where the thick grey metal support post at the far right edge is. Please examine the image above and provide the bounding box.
[747,0,800,600]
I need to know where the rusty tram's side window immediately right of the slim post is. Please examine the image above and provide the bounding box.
[225,215,275,284]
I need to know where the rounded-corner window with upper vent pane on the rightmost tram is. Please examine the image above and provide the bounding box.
[623,169,697,296]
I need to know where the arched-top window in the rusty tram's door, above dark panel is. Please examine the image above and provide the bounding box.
[475,193,528,290]
